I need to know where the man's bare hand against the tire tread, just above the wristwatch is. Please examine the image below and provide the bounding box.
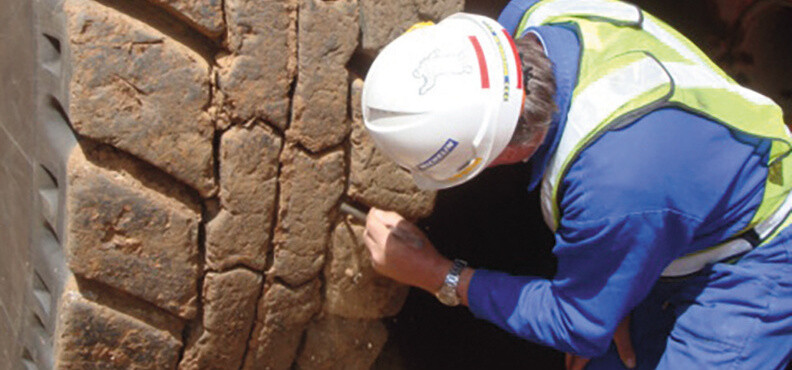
[363,208,452,293]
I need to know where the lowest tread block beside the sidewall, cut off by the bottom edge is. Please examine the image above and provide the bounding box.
[55,283,182,370]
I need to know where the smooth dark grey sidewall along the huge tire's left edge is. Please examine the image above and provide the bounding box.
[0,0,76,369]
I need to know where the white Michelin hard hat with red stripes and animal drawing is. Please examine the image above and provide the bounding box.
[362,13,525,189]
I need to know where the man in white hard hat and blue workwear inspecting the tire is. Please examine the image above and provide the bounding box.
[363,0,792,369]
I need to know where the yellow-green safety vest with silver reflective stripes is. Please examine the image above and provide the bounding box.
[515,0,792,276]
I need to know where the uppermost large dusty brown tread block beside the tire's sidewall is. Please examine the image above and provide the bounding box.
[64,0,216,197]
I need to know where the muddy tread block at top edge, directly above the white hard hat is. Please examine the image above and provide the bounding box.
[360,0,465,56]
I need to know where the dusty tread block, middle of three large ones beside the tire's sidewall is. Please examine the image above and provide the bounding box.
[66,144,200,318]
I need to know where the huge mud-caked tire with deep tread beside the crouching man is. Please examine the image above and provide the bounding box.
[0,0,454,369]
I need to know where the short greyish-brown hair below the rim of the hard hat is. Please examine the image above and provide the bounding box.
[509,32,558,145]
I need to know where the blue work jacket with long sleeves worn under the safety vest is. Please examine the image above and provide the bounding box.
[468,0,770,357]
